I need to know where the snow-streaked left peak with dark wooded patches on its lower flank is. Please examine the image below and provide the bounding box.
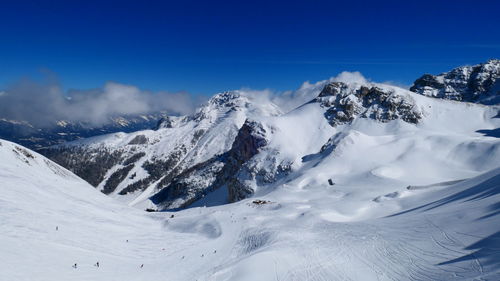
[43,91,281,208]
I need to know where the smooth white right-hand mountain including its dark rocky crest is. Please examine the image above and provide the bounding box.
[229,79,500,201]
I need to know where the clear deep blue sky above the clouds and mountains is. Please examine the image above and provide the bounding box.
[0,0,500,94]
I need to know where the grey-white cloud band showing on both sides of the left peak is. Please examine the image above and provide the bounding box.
[0,72,376,127]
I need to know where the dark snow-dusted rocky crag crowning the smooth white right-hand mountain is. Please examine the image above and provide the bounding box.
[315,82,423,126]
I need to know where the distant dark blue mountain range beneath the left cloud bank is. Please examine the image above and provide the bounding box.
[0,112,167,149]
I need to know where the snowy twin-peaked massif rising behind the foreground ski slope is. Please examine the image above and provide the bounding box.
[43,61,500,213]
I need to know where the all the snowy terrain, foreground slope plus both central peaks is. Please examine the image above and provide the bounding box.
[0,60,500,280]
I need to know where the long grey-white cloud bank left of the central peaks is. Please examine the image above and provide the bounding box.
[0,75,202,127]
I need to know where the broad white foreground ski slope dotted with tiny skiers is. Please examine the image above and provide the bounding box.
[0,138,500,280]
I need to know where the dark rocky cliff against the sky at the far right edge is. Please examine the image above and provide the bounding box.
[410,60,500,104]
